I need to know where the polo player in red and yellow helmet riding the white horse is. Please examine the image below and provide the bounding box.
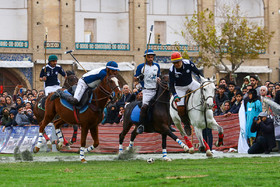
[169,52,203,136]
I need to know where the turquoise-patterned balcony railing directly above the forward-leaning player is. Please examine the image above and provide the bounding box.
[75,42,130,51]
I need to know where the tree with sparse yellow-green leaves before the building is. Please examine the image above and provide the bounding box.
[181,5,273,79]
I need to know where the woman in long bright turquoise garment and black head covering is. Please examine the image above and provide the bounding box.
[246,89,262,146]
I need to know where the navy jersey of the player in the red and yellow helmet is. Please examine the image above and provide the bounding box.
[169,59,201,95]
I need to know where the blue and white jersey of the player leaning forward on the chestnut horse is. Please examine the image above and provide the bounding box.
[82,68,107,88]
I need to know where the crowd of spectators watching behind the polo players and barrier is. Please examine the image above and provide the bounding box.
[0,76,280,153]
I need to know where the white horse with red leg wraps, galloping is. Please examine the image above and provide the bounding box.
[170,77,224,157]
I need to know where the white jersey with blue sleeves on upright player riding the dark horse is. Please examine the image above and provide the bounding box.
[134,62,160,89]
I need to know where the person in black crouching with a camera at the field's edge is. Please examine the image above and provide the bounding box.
[248,112,276,154]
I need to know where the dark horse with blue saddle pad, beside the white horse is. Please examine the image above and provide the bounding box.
[119,76,192,161]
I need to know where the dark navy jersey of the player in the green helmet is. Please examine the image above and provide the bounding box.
[40,64,66,87]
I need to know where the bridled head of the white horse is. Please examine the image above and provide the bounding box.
[200,77,215,109]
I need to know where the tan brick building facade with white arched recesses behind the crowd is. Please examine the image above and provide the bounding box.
[0,0,280,93]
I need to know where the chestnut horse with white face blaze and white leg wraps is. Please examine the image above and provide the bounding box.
[33,74,121,163]
